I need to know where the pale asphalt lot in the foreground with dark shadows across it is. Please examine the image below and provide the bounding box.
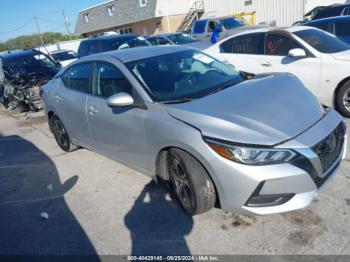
[0,108,350,255]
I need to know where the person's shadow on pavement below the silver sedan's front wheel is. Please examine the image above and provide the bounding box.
[124,181,193,256]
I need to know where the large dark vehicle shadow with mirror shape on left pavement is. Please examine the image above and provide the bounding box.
[0,135,99,261]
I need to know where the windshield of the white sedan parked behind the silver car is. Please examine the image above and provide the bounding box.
[294,29,350,54]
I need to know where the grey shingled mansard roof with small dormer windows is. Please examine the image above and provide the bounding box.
[75,0,157,34]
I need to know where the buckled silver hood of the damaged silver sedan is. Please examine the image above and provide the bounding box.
[165,74,323,146]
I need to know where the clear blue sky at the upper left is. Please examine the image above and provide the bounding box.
[0,0,106,42]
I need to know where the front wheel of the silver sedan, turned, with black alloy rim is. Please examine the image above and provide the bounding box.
[167,149,216,216]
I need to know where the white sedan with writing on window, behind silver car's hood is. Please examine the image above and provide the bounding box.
[204,26,350,117]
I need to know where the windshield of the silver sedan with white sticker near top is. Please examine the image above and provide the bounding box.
[126,50,244,103]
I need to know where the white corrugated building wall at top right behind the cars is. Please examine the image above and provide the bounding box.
[204,0,349,26]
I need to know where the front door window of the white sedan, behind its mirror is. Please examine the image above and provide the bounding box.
[265,35,301,56]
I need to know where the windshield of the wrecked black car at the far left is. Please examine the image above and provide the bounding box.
[6,53,57,70]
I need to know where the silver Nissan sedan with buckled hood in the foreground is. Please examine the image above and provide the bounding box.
[43,46,346,215]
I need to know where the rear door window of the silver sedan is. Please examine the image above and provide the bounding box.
[62,64,90,93]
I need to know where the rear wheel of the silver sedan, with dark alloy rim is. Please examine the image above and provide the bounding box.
[50,114,78,152]
